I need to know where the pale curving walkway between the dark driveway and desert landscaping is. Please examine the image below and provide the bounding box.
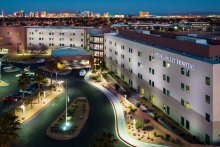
[84,71,163,147]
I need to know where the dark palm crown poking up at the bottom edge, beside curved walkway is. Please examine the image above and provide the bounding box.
[92,130,118,147]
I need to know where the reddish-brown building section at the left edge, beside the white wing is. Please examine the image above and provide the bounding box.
[0,27,27,53]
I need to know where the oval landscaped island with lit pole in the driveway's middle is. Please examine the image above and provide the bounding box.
[47,97,89,140]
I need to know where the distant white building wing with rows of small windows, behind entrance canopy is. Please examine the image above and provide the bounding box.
[27,26,93,49]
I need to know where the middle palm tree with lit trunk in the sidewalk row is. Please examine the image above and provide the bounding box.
[34,70,45,103]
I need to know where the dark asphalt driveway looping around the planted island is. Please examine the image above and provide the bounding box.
[13,69,126,147]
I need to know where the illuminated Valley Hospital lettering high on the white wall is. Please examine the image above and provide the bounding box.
[154,53,195,70]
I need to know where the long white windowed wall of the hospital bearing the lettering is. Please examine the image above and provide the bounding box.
[105,34,220,144]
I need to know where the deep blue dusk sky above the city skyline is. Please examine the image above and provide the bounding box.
[0,0,220,14]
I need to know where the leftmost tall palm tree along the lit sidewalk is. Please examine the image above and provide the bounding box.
[18,71,32,107]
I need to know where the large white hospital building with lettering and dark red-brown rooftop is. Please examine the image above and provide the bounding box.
[104,31,220,144]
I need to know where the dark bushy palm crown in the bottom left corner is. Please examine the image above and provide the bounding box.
[0,113,20,147]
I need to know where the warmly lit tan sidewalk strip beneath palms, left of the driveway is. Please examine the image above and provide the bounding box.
[15,85,64,123]
